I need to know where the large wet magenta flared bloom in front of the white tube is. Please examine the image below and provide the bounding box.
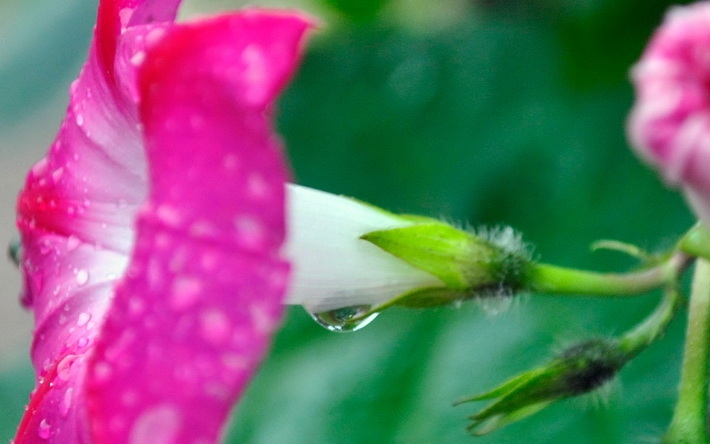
[15,0,310,444]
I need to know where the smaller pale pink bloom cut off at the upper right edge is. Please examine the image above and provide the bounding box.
[628,2,710,224]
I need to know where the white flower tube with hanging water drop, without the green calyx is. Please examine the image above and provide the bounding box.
[286,184,444,332]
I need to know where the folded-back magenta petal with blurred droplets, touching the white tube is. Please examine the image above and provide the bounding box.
[87,11,309,444]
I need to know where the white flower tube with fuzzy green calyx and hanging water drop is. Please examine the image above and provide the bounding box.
[286,185,531,332]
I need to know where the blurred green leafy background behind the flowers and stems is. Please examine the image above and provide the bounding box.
[0,0,693,444]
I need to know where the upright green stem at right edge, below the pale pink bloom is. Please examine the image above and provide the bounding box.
[662,259,710,444]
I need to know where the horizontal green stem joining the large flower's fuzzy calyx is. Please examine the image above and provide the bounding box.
[526,254,688,297]
